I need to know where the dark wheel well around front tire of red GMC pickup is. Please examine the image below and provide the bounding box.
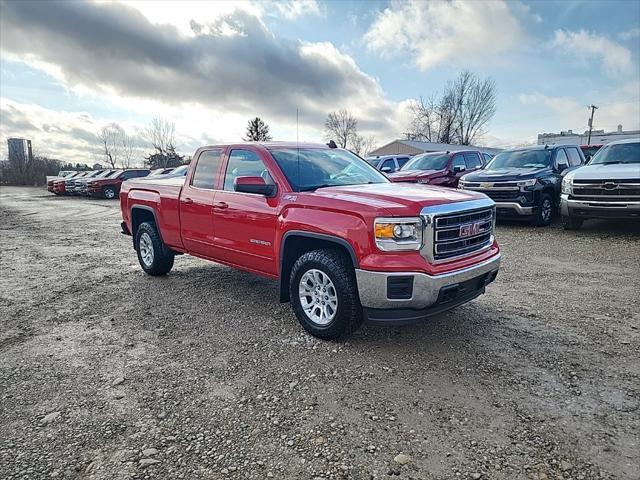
[280,230,358,303]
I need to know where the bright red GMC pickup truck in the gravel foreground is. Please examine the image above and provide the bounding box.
[120,143,500,339]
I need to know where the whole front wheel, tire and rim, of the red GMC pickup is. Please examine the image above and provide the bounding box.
[289,249,362,340]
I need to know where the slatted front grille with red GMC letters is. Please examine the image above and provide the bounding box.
[433,207,495,260]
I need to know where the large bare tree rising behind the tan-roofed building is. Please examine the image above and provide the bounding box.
[408,71,496,145]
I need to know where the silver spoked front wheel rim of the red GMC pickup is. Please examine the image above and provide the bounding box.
[298,268,338,325]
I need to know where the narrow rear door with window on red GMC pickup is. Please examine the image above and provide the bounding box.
[179,148,224,257]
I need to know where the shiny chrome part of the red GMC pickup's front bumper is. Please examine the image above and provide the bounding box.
[356,253,501,310]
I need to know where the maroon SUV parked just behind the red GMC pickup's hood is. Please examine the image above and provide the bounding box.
[387,150,491,188]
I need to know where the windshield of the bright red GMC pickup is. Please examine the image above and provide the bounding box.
[271,148,389,192]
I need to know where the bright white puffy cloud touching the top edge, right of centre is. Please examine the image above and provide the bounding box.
[364,0,536,70]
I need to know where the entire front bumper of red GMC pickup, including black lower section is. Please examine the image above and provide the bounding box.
[356,253,501,325]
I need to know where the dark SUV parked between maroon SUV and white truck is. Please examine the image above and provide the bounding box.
[459,145,585,226]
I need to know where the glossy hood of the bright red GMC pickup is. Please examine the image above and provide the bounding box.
[305,183,485,216]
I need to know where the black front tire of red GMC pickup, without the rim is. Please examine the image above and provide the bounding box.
[289,249,362,340]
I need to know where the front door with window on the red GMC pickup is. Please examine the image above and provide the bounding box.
[213,147,279,275]
